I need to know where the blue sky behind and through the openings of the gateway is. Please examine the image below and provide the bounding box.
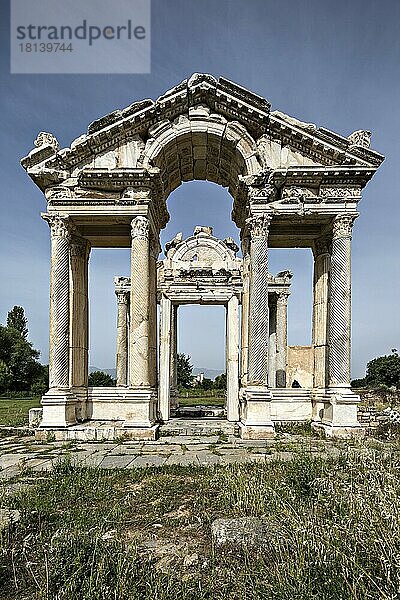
[0,0,400,376]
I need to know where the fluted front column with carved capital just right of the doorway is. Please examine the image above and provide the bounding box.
[248,215,271,386]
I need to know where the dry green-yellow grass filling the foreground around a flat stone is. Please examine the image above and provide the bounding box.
[0,446,400,600]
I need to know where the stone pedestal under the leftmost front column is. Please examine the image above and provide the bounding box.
[39,388,77,429]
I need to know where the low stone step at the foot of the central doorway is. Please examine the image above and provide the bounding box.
[160,417,239,436]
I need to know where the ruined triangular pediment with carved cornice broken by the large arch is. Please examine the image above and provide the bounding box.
[21,73,383,189]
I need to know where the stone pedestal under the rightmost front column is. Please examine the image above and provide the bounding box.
[312,385,365,438]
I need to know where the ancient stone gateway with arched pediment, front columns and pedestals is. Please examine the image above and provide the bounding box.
[22,74,383,438]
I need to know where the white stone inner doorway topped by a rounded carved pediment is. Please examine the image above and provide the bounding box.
[157,226,242,423]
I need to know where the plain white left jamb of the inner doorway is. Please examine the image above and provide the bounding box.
[159,295,172,421]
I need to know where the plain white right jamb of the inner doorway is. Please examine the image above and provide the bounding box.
[226,296,239,421]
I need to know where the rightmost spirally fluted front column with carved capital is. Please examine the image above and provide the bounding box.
[329,215,355,388]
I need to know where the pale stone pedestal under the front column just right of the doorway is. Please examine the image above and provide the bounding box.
[239,386,275,440]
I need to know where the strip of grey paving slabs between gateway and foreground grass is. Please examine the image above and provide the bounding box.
[0,434,339,479]
